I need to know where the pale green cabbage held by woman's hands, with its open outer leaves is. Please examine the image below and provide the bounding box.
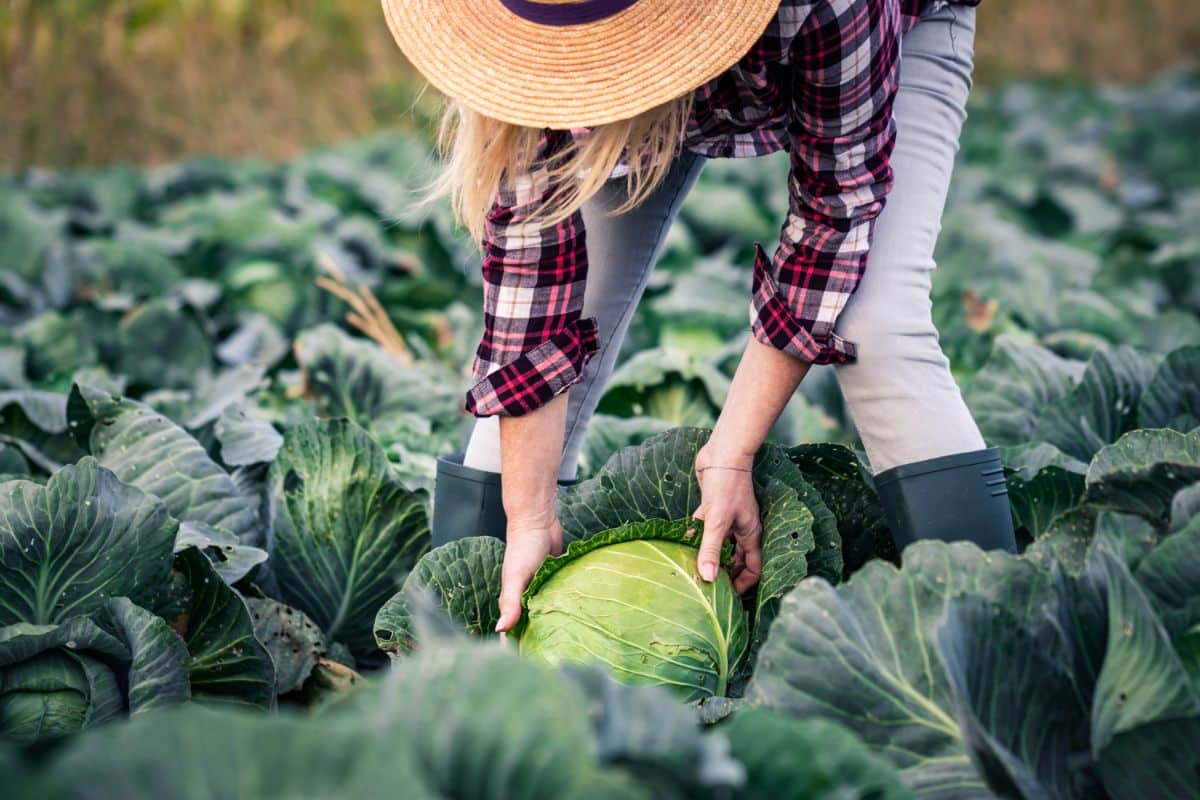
[374,428,842,699]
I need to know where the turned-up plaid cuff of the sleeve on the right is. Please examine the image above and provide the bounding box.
[750,242,858,363]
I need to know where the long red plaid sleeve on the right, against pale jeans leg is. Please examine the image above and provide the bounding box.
[750,0,900,363]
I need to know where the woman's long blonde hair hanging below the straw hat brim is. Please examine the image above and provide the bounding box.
[416,92,694,247]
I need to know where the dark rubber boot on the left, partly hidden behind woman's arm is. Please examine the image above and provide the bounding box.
[430,453,578,547]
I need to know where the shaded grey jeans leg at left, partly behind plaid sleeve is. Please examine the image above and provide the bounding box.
[464,150,707,480]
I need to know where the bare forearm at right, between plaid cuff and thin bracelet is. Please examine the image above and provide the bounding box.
[708,337,812,465]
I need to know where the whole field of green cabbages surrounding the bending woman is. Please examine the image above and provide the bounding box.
[7,72,1200,800]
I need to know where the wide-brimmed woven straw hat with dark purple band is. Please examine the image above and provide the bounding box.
[383,0,779,130]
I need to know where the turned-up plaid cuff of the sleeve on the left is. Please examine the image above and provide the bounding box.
[467,317,599,416]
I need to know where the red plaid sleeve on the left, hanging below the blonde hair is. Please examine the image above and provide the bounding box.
[466,128,598,416]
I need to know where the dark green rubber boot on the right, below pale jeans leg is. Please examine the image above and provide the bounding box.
[875,447,1016,553]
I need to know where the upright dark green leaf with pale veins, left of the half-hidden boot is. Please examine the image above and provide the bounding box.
[268,420,428,656]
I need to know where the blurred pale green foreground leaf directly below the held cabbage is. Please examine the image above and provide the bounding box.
[347,640,740,800]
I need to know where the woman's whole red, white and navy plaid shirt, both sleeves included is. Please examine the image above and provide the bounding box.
[467,0,980,416]
